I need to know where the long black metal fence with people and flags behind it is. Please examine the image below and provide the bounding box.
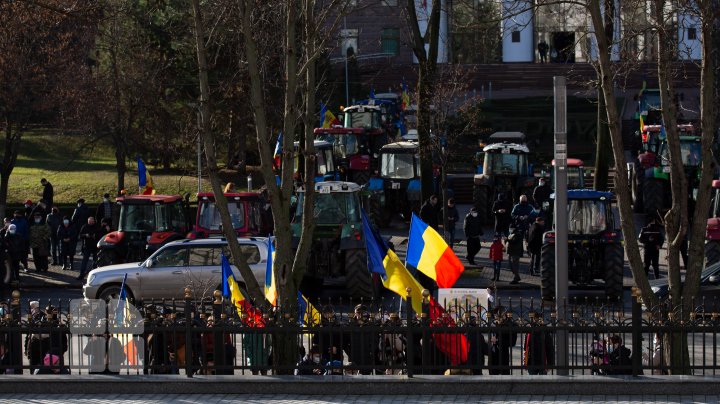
[0,288,720,377]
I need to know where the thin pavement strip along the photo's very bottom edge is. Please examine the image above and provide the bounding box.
[2,394,720,404]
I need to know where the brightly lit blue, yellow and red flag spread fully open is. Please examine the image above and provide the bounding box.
[406,213,465,288]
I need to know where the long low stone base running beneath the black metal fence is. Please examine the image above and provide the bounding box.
[0,375,720,397]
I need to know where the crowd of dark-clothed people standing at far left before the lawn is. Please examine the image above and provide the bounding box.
[0,178,113,290]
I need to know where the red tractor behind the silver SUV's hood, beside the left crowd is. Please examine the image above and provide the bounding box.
[98,195,190,266]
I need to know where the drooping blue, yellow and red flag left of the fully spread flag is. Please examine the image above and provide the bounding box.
[362,211,468,365]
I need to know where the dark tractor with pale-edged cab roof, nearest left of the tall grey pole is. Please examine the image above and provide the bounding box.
[473,132,535,223]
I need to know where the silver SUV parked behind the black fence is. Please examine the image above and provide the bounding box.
[83,237,268,301]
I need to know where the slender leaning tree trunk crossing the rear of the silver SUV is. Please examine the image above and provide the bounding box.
[192,0,265,307]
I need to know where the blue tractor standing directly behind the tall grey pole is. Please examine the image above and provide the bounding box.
[540,189,625,300]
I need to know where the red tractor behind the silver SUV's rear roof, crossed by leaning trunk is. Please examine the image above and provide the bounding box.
[188,192,267,238]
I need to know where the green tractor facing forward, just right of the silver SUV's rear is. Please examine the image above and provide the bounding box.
[292,181,373,299]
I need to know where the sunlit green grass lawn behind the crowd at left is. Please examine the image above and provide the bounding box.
[8,131,210,204]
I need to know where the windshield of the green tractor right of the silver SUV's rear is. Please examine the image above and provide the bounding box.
[295,192,360,224]
